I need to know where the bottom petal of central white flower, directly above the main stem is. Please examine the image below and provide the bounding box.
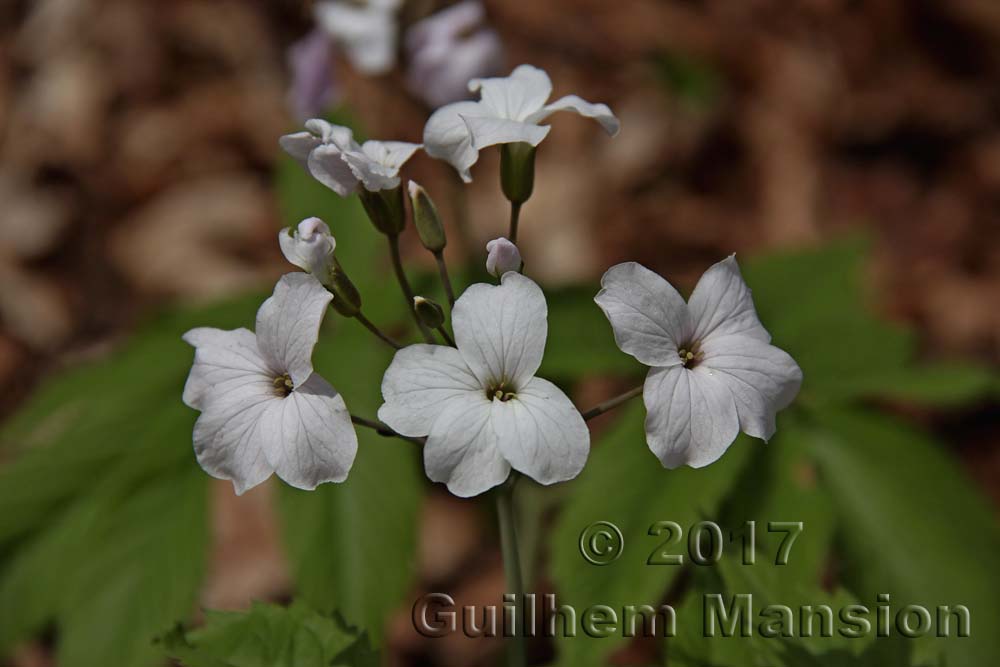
[424,392,510,498]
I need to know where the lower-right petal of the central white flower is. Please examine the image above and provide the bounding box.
[492,378,590,484]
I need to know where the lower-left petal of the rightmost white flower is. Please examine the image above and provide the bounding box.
[642,366,740,468]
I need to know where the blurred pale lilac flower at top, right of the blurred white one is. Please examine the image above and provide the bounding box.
[406,0,503,107]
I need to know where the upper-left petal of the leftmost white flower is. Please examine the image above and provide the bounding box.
[183,327,275,410]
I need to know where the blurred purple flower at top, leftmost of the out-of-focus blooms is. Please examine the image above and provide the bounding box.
[288,29,337,121]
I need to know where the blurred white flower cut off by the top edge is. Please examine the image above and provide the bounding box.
[314,0,402,75]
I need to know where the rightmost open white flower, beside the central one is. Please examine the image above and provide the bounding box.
[594,256,802,468]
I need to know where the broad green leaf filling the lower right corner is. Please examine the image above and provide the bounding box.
[809,410,1000,665]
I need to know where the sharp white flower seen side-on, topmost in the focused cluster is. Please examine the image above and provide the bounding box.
[424,65,620,183]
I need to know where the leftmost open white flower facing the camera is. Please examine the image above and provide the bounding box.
[184,273,358,494]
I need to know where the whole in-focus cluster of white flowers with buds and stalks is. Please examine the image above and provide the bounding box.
[184,65,802,496]
